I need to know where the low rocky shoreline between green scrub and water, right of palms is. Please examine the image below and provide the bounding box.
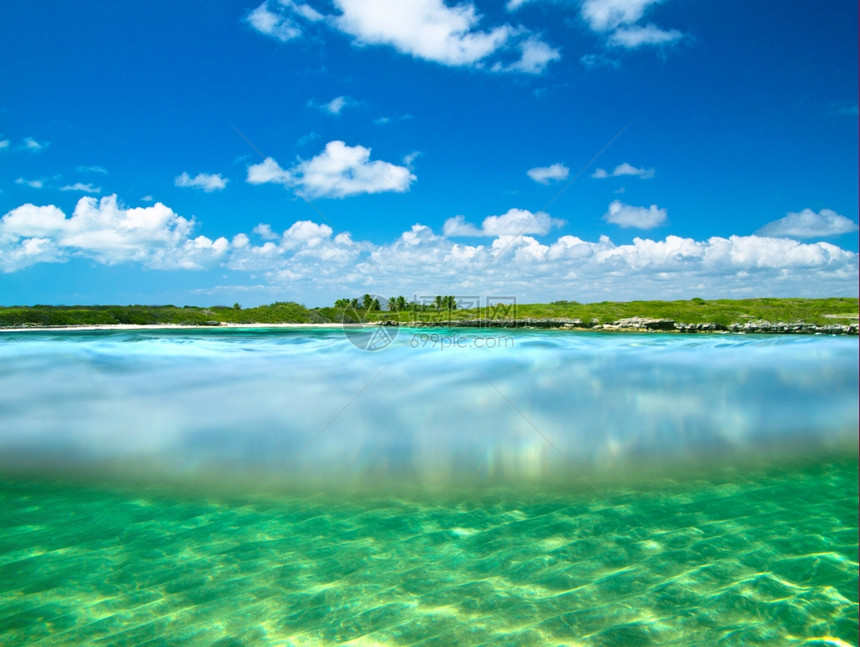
[375,317,860,335]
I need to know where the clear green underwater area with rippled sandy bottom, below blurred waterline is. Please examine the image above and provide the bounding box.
[0,459,858,646]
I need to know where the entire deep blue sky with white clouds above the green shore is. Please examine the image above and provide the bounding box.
[0,0,858,305]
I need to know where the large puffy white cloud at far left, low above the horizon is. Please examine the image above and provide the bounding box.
[0,195,228,272]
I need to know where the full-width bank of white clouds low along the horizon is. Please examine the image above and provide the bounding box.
[0,196,858,305]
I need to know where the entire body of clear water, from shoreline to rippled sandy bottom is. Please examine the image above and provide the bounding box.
[0,330,858,645]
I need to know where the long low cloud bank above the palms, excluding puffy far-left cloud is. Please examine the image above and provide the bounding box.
[222,219,857,304]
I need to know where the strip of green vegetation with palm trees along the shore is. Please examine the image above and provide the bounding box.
[0,294,858,327]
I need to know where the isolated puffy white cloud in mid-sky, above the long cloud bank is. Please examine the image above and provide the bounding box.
[248,140,416,198]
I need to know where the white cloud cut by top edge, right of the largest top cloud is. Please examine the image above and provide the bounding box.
[580,0,683,49]
